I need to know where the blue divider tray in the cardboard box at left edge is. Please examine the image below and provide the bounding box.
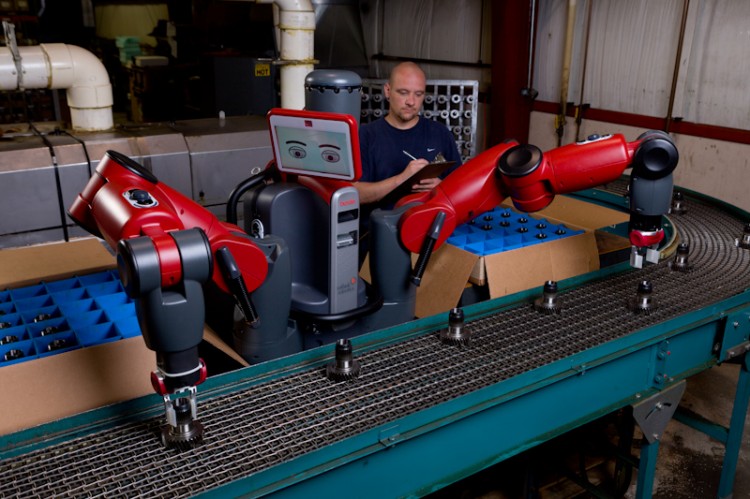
[0,270,141,367]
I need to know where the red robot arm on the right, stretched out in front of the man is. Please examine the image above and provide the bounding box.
[400,132,678,270]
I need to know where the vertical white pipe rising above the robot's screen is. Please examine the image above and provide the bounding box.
[257,0,315,109]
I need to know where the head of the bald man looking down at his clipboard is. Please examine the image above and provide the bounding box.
[383,62,426,128]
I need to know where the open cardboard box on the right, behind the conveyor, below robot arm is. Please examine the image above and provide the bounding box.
[416,196,629,317]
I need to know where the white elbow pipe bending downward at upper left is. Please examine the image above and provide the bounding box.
[0,43,113,131]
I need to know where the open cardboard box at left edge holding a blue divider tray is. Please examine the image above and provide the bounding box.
[0,238,156,434]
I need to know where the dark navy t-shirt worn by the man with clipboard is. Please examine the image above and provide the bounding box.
[359,117,461,188]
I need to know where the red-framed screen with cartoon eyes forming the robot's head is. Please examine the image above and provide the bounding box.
[269,111,359,180]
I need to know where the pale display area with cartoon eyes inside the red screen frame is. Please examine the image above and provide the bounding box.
[276,126,351,175]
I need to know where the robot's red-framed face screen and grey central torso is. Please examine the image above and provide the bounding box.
[264,108,364,318]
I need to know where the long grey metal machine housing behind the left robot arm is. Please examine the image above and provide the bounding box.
[0,116,273,248]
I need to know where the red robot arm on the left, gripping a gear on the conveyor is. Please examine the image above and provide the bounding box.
[69,151,268,447]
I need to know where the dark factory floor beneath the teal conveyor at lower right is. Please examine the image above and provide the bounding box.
[430,364,750,499]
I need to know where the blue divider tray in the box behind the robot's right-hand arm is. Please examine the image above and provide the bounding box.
[448,206,584,256]
